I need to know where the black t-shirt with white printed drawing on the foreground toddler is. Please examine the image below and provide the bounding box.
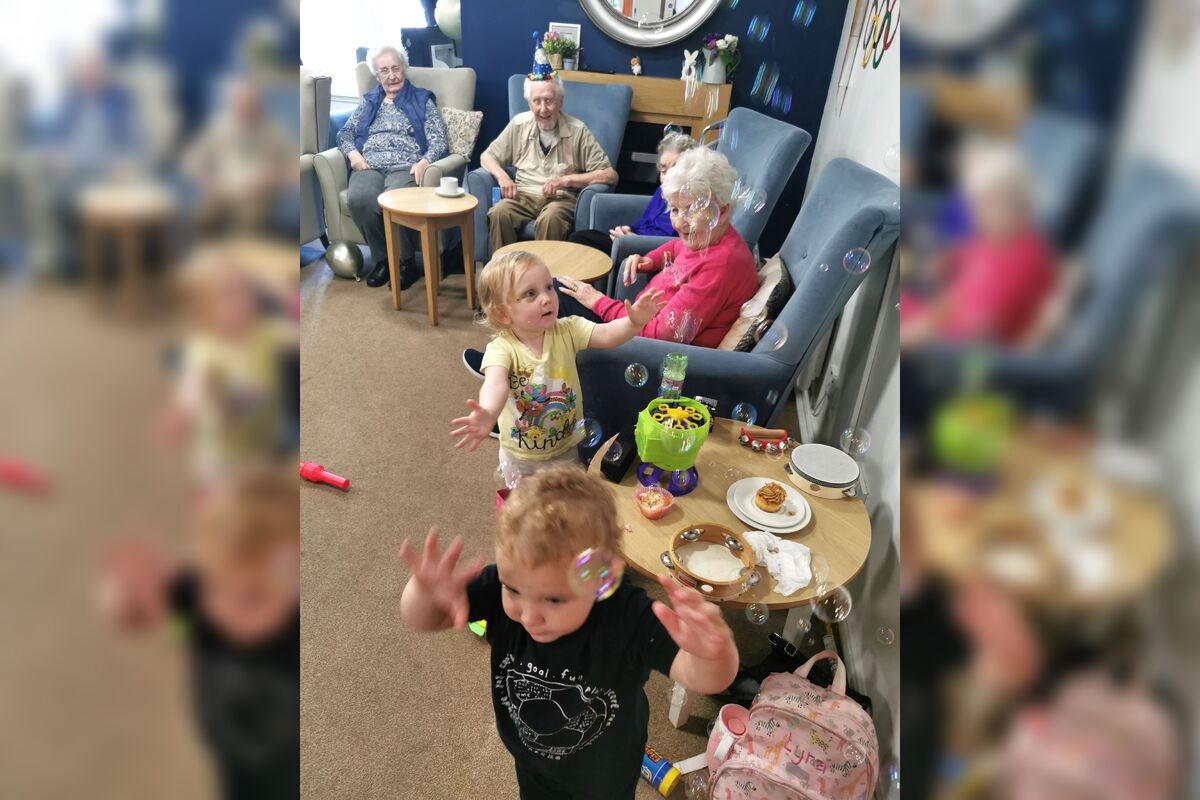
[467,565,679,800]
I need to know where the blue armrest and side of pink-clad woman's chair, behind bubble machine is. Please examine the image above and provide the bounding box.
[576,336,797,437]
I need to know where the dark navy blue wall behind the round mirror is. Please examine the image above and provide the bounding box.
[460,0,846,255]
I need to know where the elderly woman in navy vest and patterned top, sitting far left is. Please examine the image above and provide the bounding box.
[337,46,448,290]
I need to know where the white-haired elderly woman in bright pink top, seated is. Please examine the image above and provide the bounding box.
[558,148,758,348]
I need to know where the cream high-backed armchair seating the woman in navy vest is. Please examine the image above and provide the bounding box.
[314,62,475,245]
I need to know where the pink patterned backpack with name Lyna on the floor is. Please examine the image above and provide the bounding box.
[709,650,880,800]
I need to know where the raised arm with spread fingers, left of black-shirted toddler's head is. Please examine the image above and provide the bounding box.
[400,527,484,631]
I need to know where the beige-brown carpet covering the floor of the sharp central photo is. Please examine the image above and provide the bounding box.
[300,260,782,800]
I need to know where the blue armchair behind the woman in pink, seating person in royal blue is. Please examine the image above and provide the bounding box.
[575,108,812,264]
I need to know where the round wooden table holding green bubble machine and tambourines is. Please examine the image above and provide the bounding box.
[588,419,871,610]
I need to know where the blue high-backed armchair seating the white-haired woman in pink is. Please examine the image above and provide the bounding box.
[577,158,900,441]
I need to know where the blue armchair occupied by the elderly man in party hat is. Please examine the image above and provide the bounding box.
[466,76,634,261]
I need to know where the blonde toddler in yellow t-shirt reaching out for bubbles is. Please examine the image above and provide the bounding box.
[451,251,664,475]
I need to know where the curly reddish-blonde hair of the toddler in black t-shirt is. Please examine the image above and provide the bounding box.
[496,465,620,567]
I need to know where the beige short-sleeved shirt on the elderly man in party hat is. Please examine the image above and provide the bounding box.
[487,112,612,198]
